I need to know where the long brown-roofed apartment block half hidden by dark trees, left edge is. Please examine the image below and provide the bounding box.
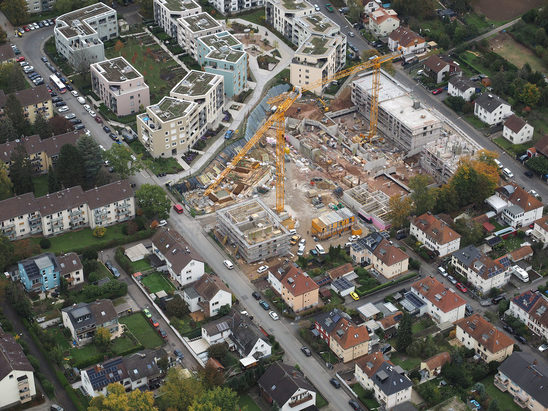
[0,131,83,174]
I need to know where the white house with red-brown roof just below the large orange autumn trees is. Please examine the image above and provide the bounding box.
[409,212,460,257]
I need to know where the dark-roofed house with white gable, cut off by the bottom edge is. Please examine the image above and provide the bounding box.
[257,362,316,411]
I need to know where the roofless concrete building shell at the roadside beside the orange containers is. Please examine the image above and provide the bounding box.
[216,199,290,263]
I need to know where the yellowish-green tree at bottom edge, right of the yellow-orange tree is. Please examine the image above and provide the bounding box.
[158,367,205,411]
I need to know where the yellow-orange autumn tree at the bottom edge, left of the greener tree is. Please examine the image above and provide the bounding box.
[88,383,158,411]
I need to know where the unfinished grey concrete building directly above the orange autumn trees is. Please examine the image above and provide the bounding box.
[420,132,483,184]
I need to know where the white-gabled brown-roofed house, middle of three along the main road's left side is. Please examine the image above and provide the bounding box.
[183,274,232,318]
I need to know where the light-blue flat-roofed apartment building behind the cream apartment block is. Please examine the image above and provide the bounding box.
[196,31,247,97]
